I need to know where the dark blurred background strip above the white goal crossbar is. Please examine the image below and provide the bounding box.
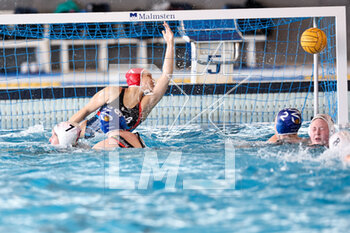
[0,0,350,57]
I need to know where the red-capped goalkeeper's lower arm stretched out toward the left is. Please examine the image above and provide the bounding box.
[69,87,120,123]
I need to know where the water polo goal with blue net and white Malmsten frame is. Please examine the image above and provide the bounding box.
[0,7,349,129]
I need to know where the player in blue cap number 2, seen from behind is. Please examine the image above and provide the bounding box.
[268,108,307,143]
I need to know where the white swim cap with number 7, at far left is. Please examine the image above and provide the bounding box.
[53,121,81,147]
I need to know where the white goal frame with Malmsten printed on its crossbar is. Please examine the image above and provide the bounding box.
[0,6,349,127]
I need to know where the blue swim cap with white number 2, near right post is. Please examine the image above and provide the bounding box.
[276,108,302,135]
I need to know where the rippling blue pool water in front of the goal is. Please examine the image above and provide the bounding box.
[0,124,350,232]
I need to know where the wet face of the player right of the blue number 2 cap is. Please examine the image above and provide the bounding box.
[310,119,329,145]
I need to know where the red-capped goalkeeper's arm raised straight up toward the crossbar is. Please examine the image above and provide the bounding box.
[145,22,174,111]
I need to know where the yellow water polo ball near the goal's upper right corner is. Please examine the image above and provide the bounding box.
[300,28,327,54]
